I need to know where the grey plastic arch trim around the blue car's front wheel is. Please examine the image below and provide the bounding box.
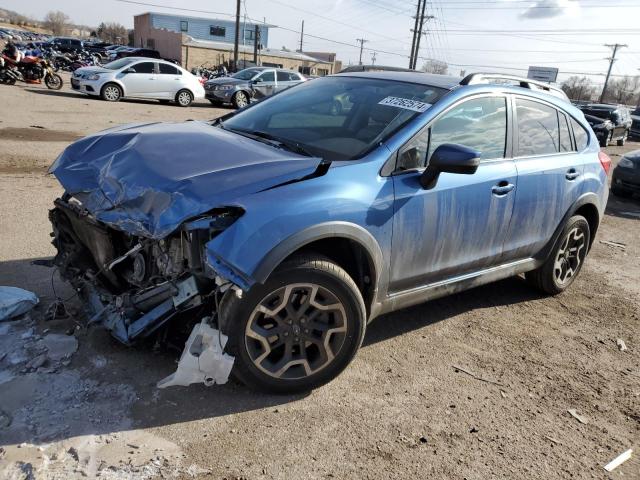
[252,221,388,310]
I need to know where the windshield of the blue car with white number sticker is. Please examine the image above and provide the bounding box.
[221,76,446,160]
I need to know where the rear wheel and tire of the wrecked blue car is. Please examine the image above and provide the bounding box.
[525,215,591,295]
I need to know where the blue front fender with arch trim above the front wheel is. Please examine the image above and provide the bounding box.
[205,158,394,290]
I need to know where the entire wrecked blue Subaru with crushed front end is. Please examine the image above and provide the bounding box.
[50,72,611,392]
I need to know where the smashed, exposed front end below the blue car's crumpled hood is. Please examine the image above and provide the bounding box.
[49,194,242,344]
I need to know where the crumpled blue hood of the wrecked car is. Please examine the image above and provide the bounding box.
[49,122,322,239]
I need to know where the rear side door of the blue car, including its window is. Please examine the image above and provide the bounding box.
[505,96,584,259]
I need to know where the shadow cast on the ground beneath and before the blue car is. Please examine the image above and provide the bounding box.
[0,255,539,445]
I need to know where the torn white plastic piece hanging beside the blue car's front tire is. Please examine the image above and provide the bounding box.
[157,318,234,388]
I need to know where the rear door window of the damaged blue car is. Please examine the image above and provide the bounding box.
[516,98,560,157]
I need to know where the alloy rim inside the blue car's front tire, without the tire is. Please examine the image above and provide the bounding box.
[245,283,347,380]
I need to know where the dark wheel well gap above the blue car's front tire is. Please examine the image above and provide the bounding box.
[283,237,377,316]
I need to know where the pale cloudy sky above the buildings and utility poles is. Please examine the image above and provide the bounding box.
[7,0,640,84]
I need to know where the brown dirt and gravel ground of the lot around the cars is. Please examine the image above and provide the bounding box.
[0,78,640,480]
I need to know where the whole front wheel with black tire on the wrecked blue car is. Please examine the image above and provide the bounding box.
[219,255,366,393]
